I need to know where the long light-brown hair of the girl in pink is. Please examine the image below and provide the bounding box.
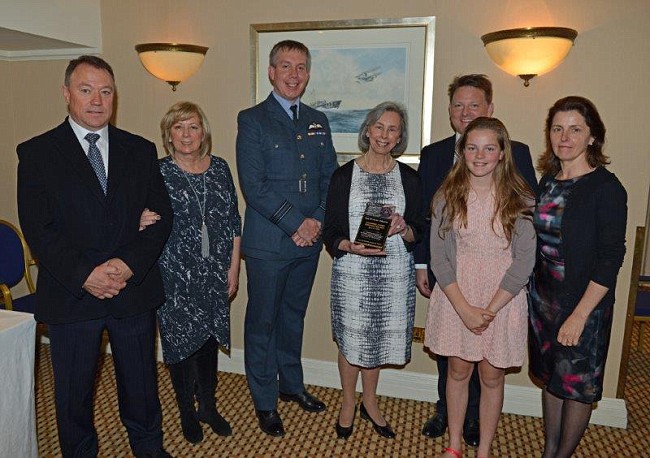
[431,117,534,243]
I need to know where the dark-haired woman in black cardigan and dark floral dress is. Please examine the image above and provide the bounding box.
[529,96,627,458]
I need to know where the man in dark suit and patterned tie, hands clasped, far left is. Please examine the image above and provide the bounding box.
[17,56,172,457]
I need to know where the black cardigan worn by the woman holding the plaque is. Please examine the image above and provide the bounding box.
[323,160,426,258]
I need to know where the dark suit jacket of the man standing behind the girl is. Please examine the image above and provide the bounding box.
[415,134,537,266]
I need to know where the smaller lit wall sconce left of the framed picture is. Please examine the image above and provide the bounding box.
[135,43,208,91]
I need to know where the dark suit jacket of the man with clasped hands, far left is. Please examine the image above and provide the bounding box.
[17,119,172,324]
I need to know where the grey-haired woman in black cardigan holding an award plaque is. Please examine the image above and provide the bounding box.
[323,102,426,439]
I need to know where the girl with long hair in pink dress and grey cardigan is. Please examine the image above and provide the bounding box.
[425,118,535,458]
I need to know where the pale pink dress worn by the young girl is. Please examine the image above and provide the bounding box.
[424,192,528,368]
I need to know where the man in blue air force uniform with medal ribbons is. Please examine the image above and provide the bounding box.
[237,40,337,436]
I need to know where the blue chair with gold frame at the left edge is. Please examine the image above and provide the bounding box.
[0,219,36,313]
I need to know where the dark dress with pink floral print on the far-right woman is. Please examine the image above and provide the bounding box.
[529,177,612,403]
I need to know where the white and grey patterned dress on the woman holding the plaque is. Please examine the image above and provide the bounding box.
[331,163,415,368]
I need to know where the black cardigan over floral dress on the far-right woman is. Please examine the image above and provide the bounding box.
[538,167,627,310]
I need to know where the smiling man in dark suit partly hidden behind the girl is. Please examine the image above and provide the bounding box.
[415,74,537,446]
